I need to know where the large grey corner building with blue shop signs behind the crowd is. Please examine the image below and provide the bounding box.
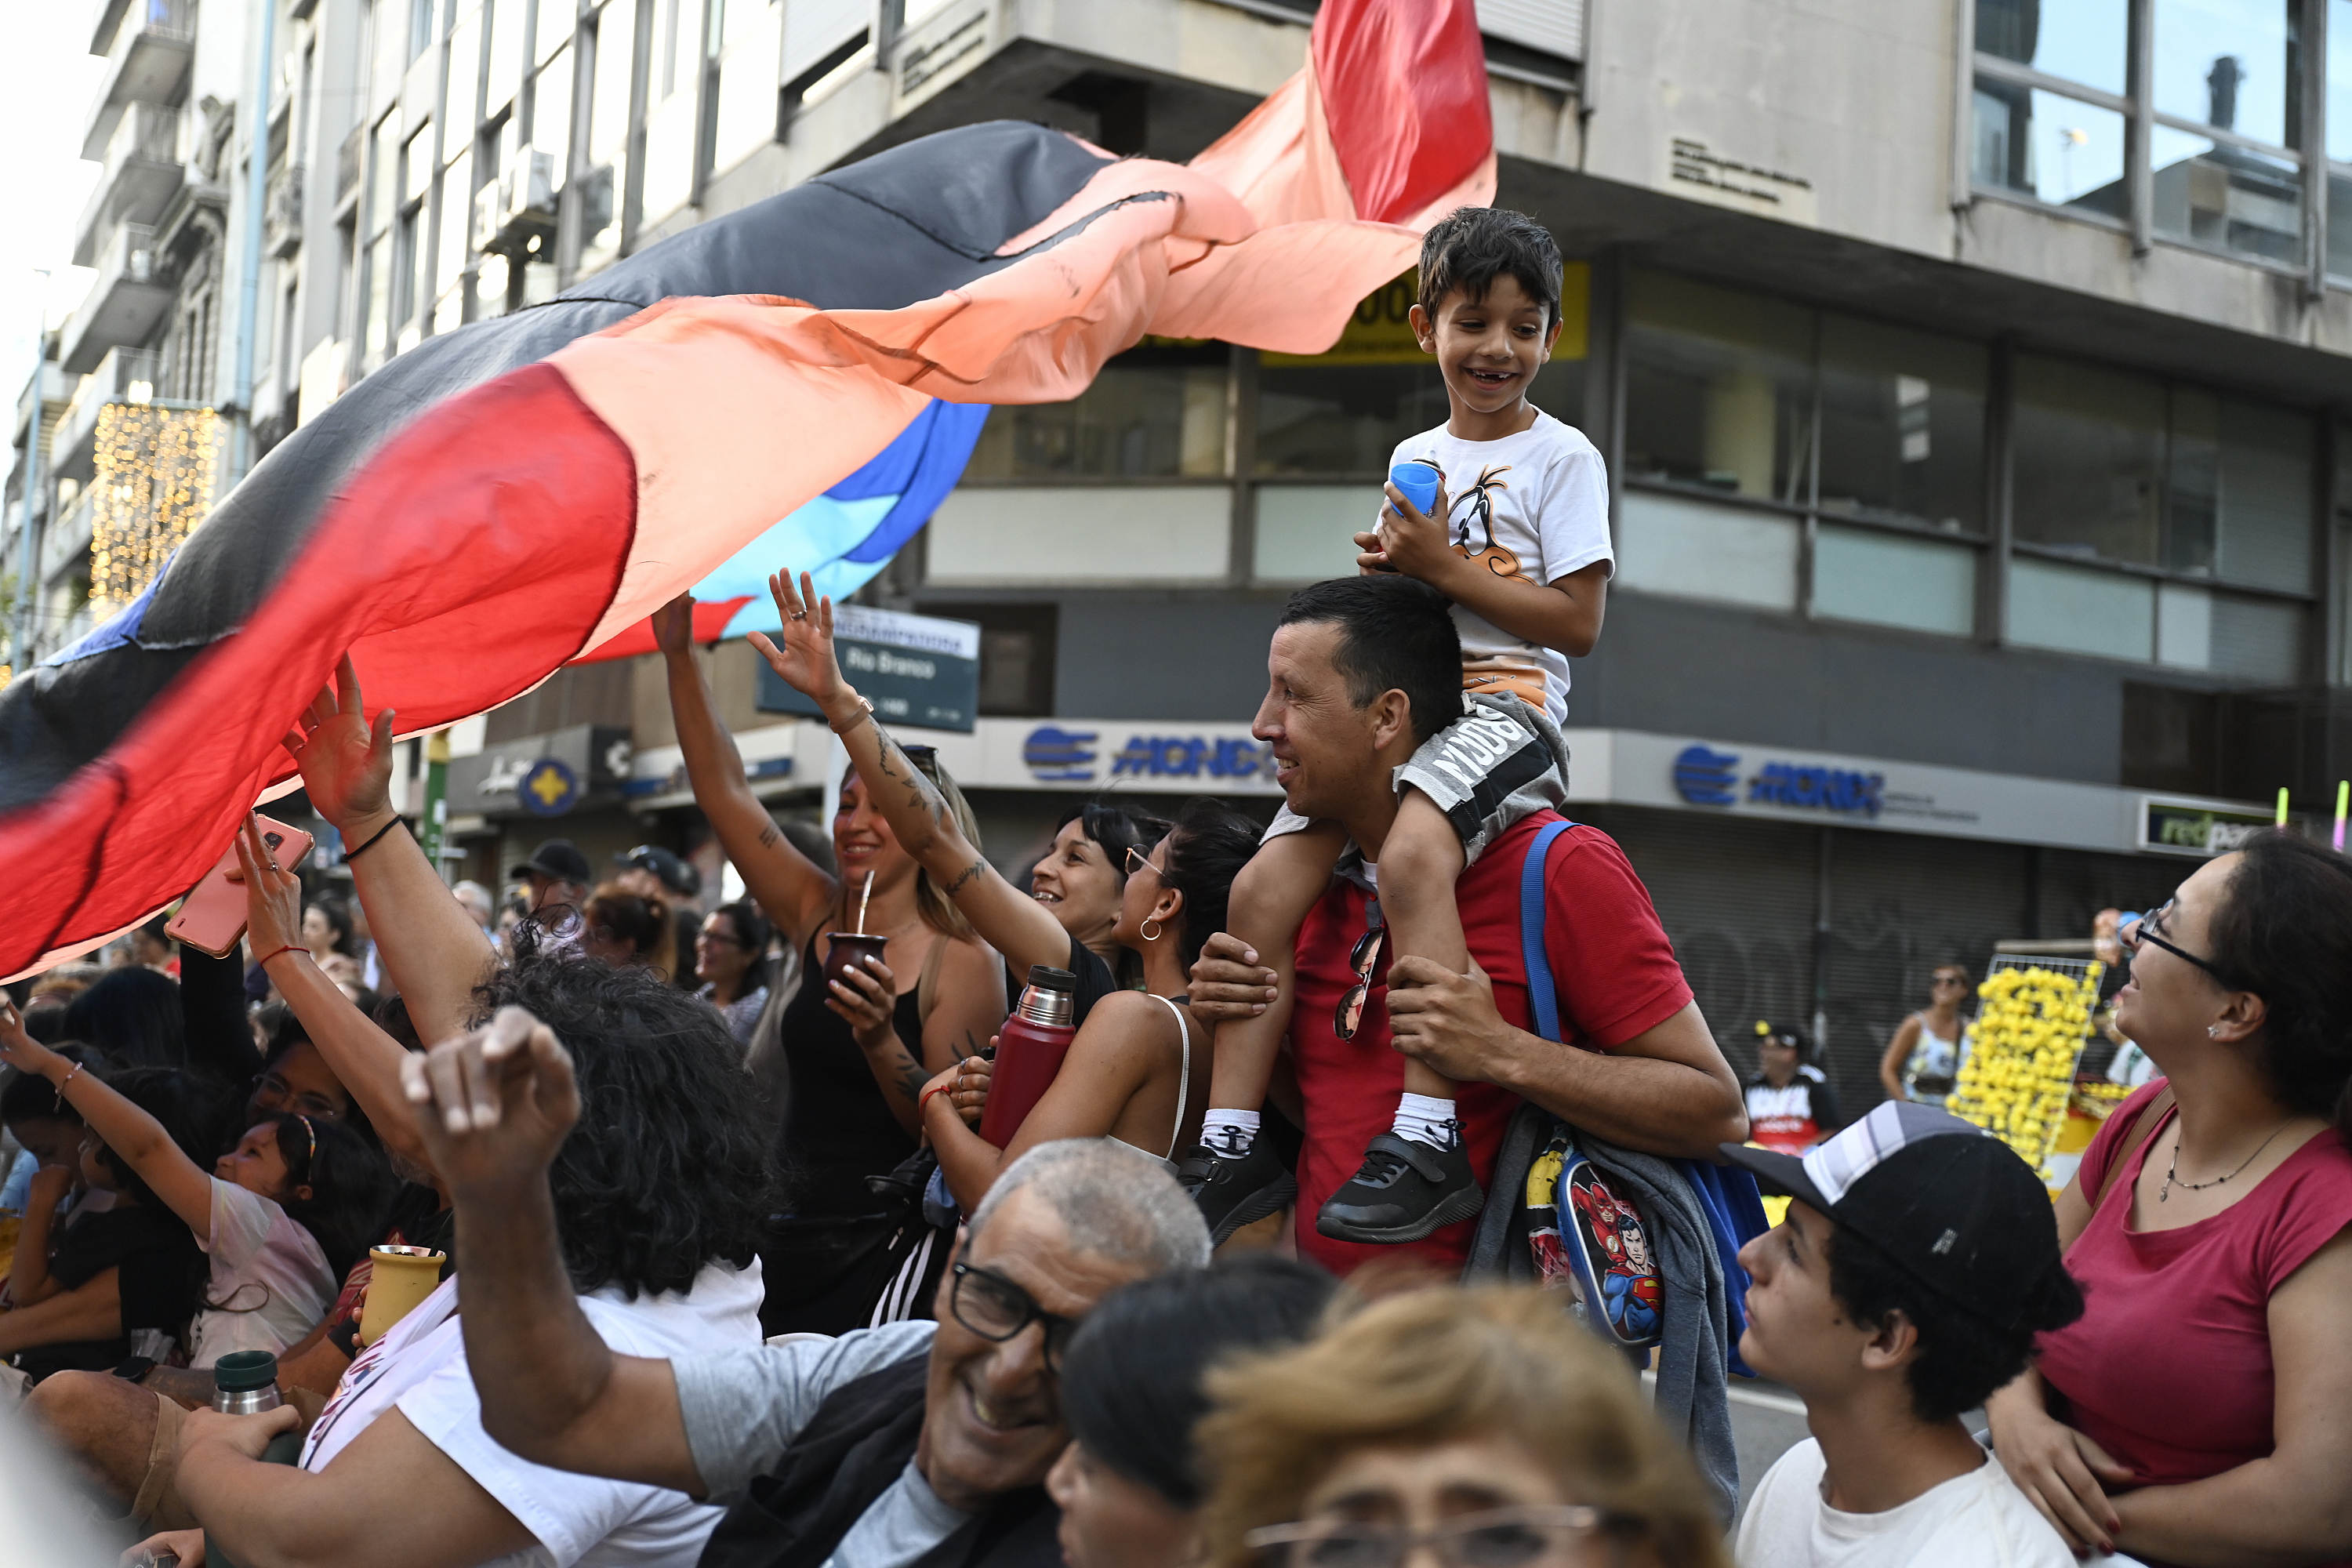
[19,0,2352,1102]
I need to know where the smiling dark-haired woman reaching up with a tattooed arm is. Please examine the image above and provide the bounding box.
[743,572,1167,1022]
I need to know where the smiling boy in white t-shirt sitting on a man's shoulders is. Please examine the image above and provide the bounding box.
[1183,207,1613,1241]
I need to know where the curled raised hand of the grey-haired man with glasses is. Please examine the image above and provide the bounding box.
[400,1006,581,1196]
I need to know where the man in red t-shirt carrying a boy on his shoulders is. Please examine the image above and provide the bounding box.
[1190,579,1748,1274]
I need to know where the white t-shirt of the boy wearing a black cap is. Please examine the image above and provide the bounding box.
[1731,1439,2077,1568]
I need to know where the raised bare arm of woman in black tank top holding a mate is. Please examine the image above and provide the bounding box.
[654,595,840,947]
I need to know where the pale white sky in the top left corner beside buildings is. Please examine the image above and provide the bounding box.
[0,0,106,491]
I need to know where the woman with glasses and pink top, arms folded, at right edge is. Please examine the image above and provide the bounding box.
[1987,832,2352,1563]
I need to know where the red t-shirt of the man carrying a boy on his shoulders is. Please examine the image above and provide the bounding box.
[1291,811,1691,1274]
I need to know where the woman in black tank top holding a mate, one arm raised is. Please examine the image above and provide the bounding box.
[654,597,1004,1333]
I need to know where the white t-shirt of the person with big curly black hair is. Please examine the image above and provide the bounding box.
[301,1260,762,1568]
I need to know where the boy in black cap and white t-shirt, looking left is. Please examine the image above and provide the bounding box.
[1722,1100,2082,1568]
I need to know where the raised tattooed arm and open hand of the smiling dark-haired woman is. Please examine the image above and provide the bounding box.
[748,574,1070,973]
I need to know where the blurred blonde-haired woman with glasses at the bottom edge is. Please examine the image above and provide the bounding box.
[1197,1288,1729,1568]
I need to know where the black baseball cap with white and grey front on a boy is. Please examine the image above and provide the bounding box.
[1722,1100,2060,1328]
